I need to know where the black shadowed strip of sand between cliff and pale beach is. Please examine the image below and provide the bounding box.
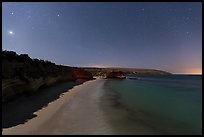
[2,81,85,128]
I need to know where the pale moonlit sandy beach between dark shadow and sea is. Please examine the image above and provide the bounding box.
[2,79,112,135]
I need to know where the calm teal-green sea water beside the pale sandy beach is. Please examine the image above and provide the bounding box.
[101,75,202,135]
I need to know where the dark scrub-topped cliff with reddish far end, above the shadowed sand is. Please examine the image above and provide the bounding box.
[2,51,93,102]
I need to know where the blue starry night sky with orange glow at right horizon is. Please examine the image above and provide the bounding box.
[2,2,202,73]
